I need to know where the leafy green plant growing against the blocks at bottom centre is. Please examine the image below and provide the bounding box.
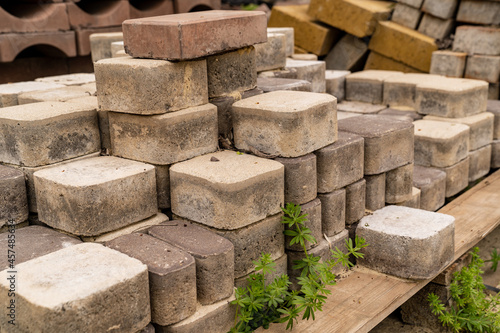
[230,204,368,333]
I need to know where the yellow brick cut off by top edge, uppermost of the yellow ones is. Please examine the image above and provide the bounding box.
[308,0,394,38]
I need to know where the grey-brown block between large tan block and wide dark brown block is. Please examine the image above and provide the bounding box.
[314,131,364,193]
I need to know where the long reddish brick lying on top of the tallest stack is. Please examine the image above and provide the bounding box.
[122,10,267,60]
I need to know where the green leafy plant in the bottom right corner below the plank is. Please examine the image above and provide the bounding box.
[428,247,500,333]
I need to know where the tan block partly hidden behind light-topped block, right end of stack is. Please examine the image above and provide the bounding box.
[424,112,495,151]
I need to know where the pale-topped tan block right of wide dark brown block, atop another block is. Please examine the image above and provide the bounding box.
[414,120,470,167]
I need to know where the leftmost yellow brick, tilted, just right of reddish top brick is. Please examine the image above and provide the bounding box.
[268,5,341,55]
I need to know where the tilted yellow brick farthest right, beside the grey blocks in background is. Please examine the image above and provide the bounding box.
[368,22,438,73]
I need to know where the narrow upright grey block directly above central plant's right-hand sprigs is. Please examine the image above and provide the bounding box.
[318,188,346,237]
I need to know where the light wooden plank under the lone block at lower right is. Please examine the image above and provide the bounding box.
[257,170,500,333]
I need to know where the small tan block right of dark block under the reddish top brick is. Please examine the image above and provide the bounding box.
[255,33,286,72]
